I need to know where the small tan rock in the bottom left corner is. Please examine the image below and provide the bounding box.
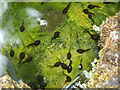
[0,75,31,89]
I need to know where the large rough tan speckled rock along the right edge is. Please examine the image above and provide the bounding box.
[87,11,120,88]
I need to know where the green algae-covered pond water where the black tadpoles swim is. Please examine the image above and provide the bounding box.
[1,2,119,88]
